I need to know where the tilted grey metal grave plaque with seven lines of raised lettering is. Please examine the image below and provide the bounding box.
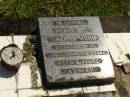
[38,17,114,84]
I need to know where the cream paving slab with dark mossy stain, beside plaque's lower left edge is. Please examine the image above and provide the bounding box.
[18,62,42,89]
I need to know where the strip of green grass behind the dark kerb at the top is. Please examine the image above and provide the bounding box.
[0,0,130,17]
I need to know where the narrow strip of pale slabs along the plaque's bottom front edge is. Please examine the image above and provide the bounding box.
[48,84,116,97]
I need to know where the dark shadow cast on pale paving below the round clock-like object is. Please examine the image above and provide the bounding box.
[0,62,16,78]
